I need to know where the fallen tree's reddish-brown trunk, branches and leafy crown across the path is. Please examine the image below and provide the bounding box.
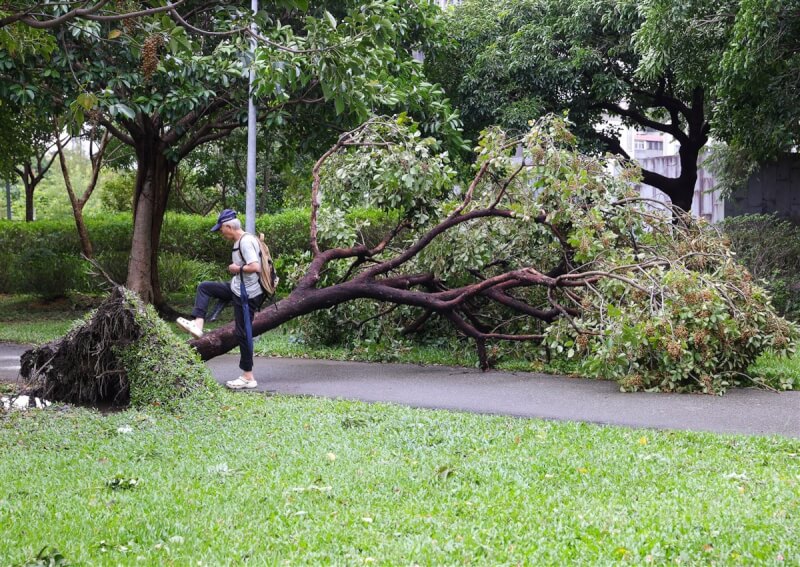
[191,116,798,393]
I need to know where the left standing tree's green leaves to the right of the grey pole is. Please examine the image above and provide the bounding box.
[248,1,462,144]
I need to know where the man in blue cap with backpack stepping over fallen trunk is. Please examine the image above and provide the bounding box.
[176,209,264,390]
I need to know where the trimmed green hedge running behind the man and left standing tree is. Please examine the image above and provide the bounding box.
[0,209,390,298]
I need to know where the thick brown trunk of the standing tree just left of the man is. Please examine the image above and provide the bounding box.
[125,137,174,306]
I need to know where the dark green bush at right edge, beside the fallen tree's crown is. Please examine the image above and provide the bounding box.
[721,215,800,321]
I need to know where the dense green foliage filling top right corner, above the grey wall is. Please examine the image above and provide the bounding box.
[636,0,800,191]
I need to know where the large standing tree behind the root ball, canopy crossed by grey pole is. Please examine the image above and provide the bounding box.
[0,0,458,308]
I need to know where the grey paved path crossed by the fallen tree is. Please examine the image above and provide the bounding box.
[0,343,800,438]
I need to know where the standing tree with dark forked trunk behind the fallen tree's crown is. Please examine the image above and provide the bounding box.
[426,0,738,211]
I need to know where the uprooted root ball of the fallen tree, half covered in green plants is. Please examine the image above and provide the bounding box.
[21,287,213,408]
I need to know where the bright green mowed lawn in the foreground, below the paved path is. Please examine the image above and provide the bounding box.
[0,392,800,565]
